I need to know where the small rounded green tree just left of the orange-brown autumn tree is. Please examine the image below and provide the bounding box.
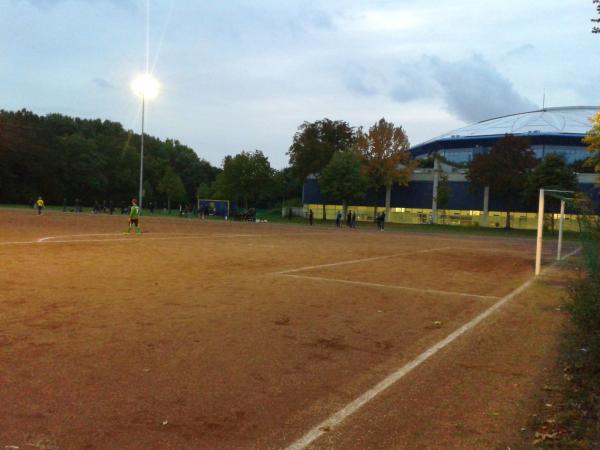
[319,152,368,216]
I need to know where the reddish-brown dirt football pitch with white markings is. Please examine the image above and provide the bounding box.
[0,210,571,449]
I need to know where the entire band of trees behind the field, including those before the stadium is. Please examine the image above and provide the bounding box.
[0,110,597,222]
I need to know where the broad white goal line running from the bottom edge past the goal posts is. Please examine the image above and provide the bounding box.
[287,244,581,450]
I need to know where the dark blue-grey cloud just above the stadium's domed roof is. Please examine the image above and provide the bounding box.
[430,55,537,122]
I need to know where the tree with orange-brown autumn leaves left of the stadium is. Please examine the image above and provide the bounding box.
[354,118,415,217]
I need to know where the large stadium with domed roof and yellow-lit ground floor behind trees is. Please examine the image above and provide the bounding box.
[303,106,600,228]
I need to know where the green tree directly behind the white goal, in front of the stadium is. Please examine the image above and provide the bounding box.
[524,154,578,229]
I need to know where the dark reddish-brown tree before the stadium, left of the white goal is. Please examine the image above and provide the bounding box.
[467,134,536,228]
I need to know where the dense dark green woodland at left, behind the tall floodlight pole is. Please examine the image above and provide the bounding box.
[0,110,219,205]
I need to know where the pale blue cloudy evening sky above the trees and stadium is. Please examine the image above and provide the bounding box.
[0,0,600,169]
